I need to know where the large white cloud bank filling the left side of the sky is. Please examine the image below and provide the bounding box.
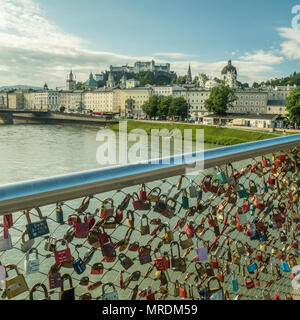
[0,0,157,87]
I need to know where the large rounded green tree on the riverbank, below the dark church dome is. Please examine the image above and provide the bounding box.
[204,84,236,115]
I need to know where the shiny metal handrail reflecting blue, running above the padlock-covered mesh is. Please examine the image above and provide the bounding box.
[0,134,300,215]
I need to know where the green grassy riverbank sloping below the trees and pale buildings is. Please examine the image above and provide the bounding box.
[109,120,290,146]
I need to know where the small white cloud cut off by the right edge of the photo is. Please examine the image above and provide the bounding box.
[277,28,300,60]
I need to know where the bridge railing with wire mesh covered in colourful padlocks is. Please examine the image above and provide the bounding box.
[0,135,300,300]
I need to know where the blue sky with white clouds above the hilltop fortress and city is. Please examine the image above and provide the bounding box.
[0,0,300,89]
